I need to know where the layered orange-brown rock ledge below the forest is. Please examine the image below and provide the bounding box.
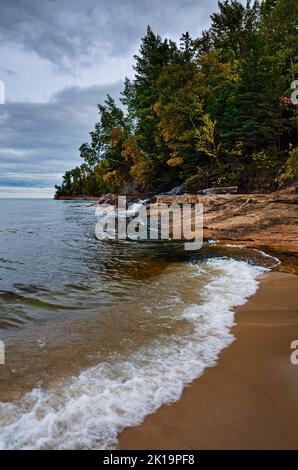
[157,183,298,272]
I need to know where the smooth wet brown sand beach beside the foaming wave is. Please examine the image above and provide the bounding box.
[119,272,298,450]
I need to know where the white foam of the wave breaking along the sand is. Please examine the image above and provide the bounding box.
[0,259,264,449]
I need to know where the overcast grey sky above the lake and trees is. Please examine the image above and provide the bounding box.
[0,0,228,197]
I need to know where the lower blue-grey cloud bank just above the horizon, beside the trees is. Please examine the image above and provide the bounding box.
[0,82,123,187]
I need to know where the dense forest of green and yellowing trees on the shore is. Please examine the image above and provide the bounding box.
[56,0,298,198]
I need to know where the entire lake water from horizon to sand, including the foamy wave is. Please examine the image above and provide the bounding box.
[0,200,272,448]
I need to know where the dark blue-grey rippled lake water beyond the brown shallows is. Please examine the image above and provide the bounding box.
[0,199,176,333]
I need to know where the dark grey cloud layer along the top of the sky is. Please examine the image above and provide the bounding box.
[0,0,217,68]
